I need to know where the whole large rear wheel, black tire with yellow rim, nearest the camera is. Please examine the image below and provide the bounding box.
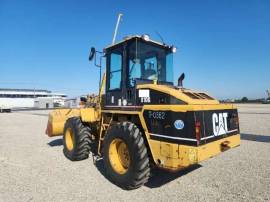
[103,122,150,189]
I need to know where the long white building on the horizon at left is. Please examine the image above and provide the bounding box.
[0,88,66,109]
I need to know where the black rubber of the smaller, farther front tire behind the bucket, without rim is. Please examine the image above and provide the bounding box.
[63,117,91,161]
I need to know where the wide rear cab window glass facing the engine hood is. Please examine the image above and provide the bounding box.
[128,40,173,87]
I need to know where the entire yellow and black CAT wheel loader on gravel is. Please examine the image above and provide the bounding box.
[47,35,240,189]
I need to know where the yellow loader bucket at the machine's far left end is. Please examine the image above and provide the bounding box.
[46,109,80,137]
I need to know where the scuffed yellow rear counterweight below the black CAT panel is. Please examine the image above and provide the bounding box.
[149,134,240,171]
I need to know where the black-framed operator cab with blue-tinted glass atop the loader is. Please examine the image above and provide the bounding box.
[105,35,176,108]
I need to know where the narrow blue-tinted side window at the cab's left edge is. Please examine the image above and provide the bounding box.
[109,53,122,90]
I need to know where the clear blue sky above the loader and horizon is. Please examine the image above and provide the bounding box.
[0,0,270,99]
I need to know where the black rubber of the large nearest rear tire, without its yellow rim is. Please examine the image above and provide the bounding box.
[103,122,150,190]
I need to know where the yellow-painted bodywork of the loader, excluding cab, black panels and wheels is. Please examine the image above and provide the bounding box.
[47,80,240,171]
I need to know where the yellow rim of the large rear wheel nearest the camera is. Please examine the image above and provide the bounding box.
[109,138,130,174]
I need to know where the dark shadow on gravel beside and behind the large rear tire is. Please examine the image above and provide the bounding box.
[95,159,202,188]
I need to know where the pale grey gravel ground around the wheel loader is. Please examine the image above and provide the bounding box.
[0,105,270,202]
